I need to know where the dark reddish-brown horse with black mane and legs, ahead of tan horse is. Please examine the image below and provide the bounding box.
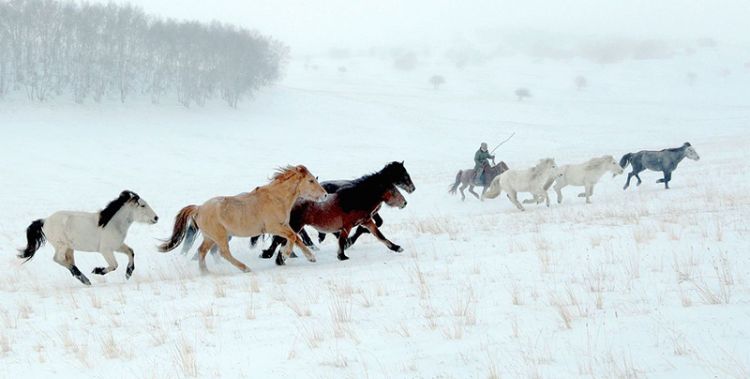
[262,162,415,264]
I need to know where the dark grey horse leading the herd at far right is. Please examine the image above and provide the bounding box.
[620,142,700,189]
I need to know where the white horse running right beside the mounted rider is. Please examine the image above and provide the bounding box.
[482,158,562,211]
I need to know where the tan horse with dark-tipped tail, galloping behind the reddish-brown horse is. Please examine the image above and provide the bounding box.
[159,165,326,272]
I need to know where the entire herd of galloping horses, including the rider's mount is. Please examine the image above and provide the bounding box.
[18,142,699,285]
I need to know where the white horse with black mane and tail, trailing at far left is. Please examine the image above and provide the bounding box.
[18,191,159,285]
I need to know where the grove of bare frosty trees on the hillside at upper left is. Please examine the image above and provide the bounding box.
[0,0,289,107]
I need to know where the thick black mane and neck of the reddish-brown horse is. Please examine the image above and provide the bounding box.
[336,162,398,212]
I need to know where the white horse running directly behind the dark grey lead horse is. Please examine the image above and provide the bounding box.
[523,155,623,204]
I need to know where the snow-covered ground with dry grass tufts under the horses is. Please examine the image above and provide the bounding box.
[0,52,750,378]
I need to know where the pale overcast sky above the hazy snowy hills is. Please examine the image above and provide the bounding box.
[103,0,750,53]
